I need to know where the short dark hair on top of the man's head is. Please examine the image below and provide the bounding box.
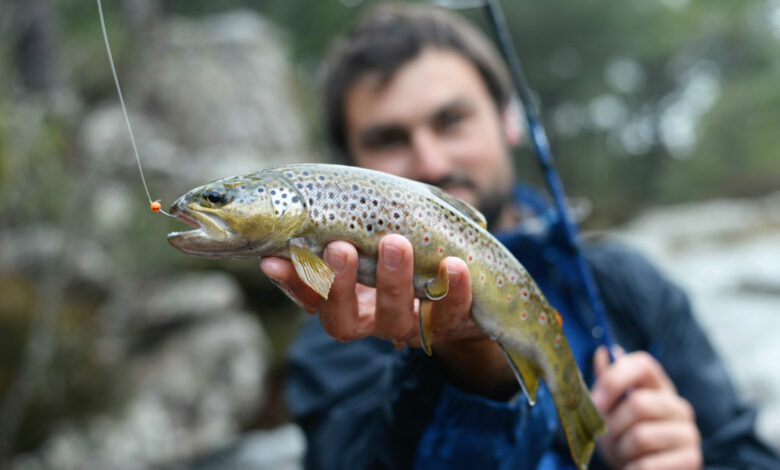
[323,4,512,156]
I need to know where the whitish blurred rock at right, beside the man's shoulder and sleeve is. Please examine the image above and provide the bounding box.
[615,193,780,450]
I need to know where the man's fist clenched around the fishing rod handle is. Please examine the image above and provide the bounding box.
[592,346,703,470]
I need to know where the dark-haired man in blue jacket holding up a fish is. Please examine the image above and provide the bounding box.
[261,6,780,469]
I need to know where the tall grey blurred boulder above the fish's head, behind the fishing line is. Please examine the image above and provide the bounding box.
[81,10,312,194]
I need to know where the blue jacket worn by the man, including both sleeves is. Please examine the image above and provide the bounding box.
[287,188,780,470]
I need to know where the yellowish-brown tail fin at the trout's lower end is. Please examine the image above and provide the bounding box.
[553,384,607,470]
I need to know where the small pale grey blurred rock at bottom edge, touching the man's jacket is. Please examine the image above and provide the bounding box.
[176,424,306,470]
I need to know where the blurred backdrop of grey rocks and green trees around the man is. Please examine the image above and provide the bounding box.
[0,0,780,470]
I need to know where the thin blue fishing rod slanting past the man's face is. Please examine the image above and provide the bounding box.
[433,0,615,362]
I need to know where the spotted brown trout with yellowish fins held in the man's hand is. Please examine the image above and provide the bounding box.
[168,164,605,469]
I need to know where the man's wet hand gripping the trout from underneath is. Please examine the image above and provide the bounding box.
[260,235,517,398]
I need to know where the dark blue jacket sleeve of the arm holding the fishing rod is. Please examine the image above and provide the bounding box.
[587,245,780,470]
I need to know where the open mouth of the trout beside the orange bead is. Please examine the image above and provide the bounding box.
[168,204,246,257]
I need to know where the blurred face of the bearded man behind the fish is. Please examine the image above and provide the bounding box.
[345,48,518,227]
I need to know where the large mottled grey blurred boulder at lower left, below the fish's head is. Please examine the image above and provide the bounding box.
[11,312,268,470]
